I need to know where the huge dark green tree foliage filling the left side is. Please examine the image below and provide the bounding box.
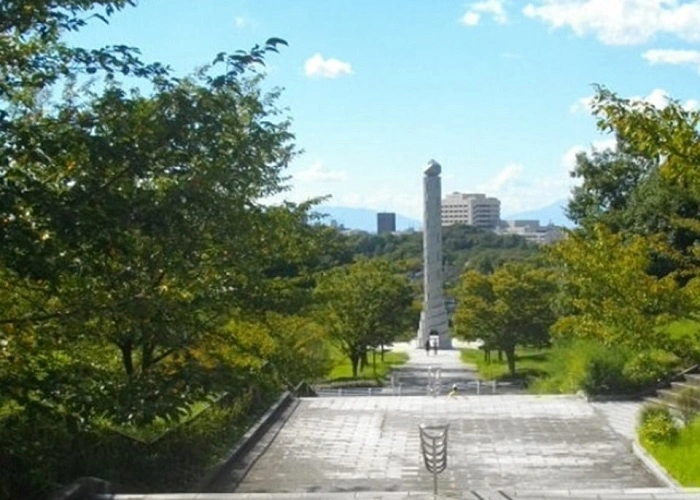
[0,0,321,428]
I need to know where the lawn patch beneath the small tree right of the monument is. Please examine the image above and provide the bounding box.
[460,347,551,383]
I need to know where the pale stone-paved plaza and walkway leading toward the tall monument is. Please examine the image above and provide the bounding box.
[231,349,663,492]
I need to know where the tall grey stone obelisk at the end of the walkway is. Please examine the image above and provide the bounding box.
[417,160,452,349]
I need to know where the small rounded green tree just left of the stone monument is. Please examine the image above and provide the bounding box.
[316,259,413,377]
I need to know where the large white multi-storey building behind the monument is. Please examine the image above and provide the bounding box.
[442,193,501,229]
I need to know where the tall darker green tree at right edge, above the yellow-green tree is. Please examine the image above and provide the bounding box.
[568,87,700,274]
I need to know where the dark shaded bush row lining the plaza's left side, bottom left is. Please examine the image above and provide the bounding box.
[0,393,276,500]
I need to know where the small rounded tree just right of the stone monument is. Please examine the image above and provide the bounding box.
[453,262,556,376]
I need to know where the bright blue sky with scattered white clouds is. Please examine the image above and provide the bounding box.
[69,0,700,218]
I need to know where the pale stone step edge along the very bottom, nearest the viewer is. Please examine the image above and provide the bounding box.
[92,488,700,500]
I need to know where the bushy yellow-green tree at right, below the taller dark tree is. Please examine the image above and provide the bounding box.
[549,226,689,350]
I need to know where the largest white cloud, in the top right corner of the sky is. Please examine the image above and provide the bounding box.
[523,0,700,45]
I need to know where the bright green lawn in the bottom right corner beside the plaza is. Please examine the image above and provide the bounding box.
[642,418,700,487]
